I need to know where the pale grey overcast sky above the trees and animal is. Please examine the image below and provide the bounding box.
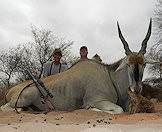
[0,0,156,63]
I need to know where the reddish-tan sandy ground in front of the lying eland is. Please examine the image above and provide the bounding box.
[0,103,162,132]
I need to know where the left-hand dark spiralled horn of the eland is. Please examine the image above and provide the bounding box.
[117,22,132,55]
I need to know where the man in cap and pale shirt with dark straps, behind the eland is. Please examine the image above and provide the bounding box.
[43,48,68,77]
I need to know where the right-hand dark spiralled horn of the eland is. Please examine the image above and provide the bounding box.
[139,19,152,54]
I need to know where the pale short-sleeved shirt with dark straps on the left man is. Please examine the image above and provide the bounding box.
[43,61,68,77]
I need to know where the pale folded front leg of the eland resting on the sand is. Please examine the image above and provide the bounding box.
[92,101,123,114]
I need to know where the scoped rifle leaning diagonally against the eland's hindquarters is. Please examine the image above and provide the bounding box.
[26,69,55,113]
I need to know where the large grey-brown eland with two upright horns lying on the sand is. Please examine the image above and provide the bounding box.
[1,20,152,114]
